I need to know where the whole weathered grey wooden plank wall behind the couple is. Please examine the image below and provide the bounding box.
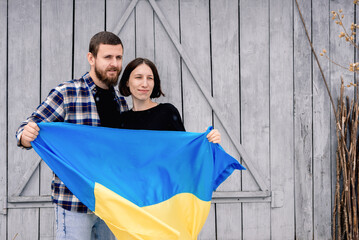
[0,0,352,240]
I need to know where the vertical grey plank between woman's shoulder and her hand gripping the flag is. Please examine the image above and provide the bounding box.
[180,0,216,239]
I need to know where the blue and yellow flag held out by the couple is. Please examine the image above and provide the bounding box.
[32,123,244,240]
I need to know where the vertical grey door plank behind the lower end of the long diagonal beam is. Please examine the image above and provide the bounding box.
[240,0,271,239]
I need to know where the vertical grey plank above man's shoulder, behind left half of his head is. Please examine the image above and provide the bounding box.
[73,0,105,78]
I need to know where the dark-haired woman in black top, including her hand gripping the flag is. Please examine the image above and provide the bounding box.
[118,58,221,143]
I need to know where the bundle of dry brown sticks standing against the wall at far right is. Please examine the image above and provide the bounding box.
[333,80,359,239]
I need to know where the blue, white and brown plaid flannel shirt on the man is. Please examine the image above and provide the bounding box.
[16,73,128,213]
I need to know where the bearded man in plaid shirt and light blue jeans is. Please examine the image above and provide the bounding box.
[16,31,128,240]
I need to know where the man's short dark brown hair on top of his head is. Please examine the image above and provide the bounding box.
[89,31,123,57]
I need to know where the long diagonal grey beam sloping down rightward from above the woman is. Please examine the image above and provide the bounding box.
[148,0,269,191]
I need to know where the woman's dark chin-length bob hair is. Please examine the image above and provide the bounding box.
[118,58,165,98]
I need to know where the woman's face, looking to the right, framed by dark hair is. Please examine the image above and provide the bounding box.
[127,64,155,101]
